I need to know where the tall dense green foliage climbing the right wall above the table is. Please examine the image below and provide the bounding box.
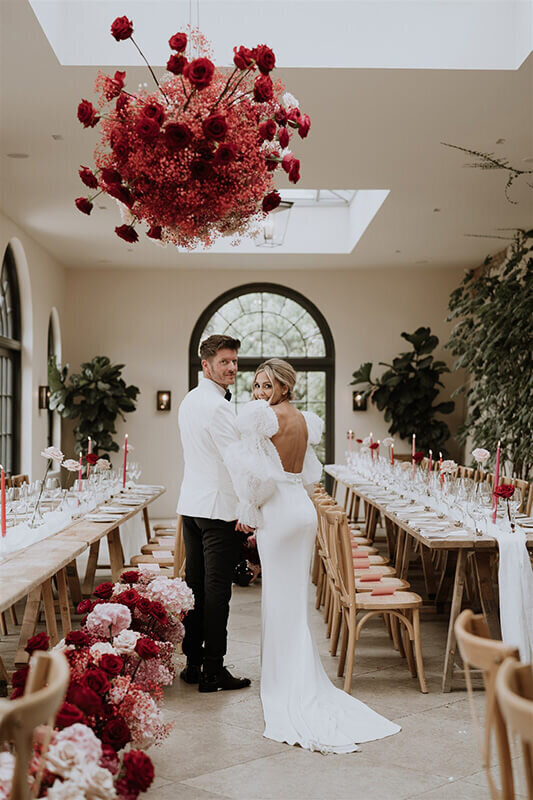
[447,230,533,478]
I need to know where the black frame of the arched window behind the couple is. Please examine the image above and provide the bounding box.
[189,283,335,463]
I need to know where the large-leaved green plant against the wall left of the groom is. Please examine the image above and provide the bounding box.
[48,356,139,453]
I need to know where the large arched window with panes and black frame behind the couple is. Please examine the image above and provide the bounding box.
[189,283,335,463]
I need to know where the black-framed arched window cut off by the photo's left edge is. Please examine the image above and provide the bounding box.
[0,246,21,475]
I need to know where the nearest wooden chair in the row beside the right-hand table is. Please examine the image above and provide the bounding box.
[326,511,427,693]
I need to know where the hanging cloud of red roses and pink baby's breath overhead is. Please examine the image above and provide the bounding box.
[72,16,311,249]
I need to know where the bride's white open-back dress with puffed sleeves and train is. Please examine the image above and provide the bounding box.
[227,400,400,753]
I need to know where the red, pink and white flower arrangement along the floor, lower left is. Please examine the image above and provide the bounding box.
[8,568,194,800]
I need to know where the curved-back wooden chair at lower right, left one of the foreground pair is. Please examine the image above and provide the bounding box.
[454,608,519,800]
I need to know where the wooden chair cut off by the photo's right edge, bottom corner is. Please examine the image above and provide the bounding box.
[496,658,533,800]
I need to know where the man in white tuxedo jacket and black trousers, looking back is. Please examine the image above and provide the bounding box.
[178,334,251,692]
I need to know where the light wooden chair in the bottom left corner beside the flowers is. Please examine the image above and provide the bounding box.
[0,652,70,800]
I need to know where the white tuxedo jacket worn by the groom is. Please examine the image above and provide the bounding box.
[178,378,239,521]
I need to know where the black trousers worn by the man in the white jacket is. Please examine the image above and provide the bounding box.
[183,516,243,673]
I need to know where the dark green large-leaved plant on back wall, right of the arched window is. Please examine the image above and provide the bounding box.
[352,328,455,452]
